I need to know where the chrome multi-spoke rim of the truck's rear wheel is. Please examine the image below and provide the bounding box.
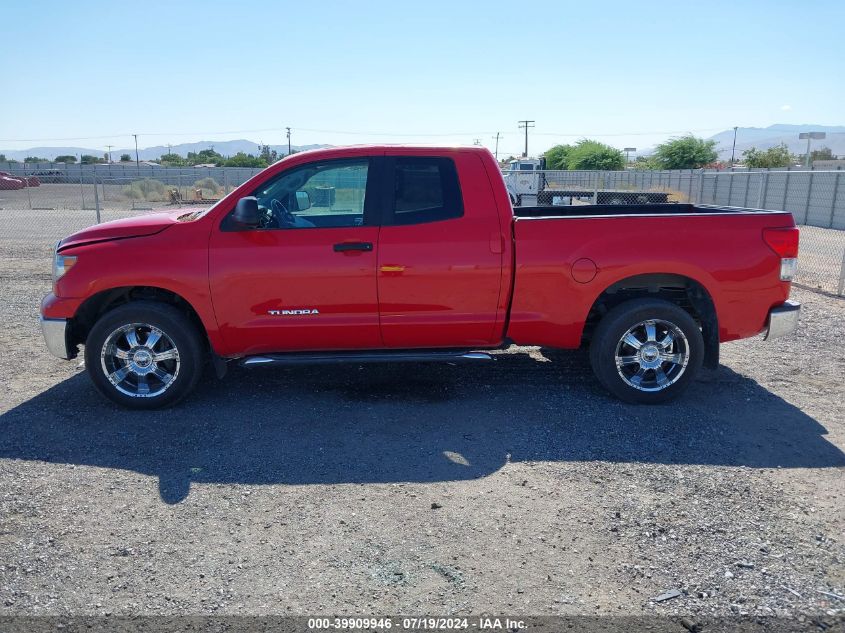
[616,319,689,391]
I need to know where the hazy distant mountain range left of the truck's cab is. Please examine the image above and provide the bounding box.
[0,139,329,161]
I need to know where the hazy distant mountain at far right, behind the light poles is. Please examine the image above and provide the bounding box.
[710,123,845,160]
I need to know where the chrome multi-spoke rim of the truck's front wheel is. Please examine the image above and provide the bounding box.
[100,323,181,398]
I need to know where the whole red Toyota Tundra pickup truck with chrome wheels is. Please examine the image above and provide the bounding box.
[41,146,799,408]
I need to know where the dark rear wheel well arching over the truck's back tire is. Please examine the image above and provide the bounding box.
[582,273,719,368]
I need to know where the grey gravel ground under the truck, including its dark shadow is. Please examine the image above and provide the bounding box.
[0,240,845,617]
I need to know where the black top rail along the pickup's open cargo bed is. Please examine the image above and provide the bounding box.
[513,203,785,218]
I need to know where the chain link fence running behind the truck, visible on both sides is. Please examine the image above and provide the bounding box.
[0,165,845,295]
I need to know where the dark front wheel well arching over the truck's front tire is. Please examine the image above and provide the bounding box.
[70,286,207,345]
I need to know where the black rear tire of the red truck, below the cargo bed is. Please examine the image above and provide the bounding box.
[590,299,704,404]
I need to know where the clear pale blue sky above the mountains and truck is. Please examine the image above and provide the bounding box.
[0,0,845,154]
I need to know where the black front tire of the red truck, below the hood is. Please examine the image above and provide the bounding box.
[85,301,205,409]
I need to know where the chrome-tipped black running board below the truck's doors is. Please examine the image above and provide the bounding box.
[241,350,494,367]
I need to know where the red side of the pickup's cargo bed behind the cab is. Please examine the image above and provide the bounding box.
[508,204,794,354]
